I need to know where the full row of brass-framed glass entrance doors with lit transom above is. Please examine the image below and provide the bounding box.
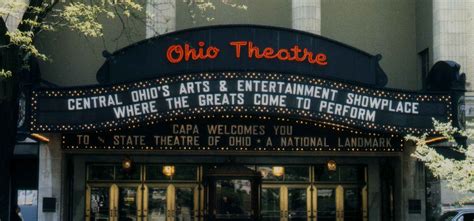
[85,164,368,221]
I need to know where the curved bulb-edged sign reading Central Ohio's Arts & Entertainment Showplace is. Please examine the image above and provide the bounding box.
[31,72,453,133]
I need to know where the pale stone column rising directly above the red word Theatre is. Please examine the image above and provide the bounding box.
[291,0,321,35]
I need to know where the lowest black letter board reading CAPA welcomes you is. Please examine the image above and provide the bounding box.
[62,118,403,152]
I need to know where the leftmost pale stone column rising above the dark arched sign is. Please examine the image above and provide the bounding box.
[146,0,176,38]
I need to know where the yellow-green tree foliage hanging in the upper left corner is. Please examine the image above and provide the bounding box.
[0,0,247,77]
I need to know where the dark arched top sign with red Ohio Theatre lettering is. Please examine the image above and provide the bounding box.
[97,25,387,87]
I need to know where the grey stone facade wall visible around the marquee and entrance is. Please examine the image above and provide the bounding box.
[14,0,474,221]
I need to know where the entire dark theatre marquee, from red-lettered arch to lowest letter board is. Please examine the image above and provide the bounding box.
[29,25,462,145]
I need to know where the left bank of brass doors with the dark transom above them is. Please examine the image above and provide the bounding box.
[86,164,203,221]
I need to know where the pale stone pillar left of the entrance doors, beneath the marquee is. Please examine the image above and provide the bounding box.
[38,134,63,221]
